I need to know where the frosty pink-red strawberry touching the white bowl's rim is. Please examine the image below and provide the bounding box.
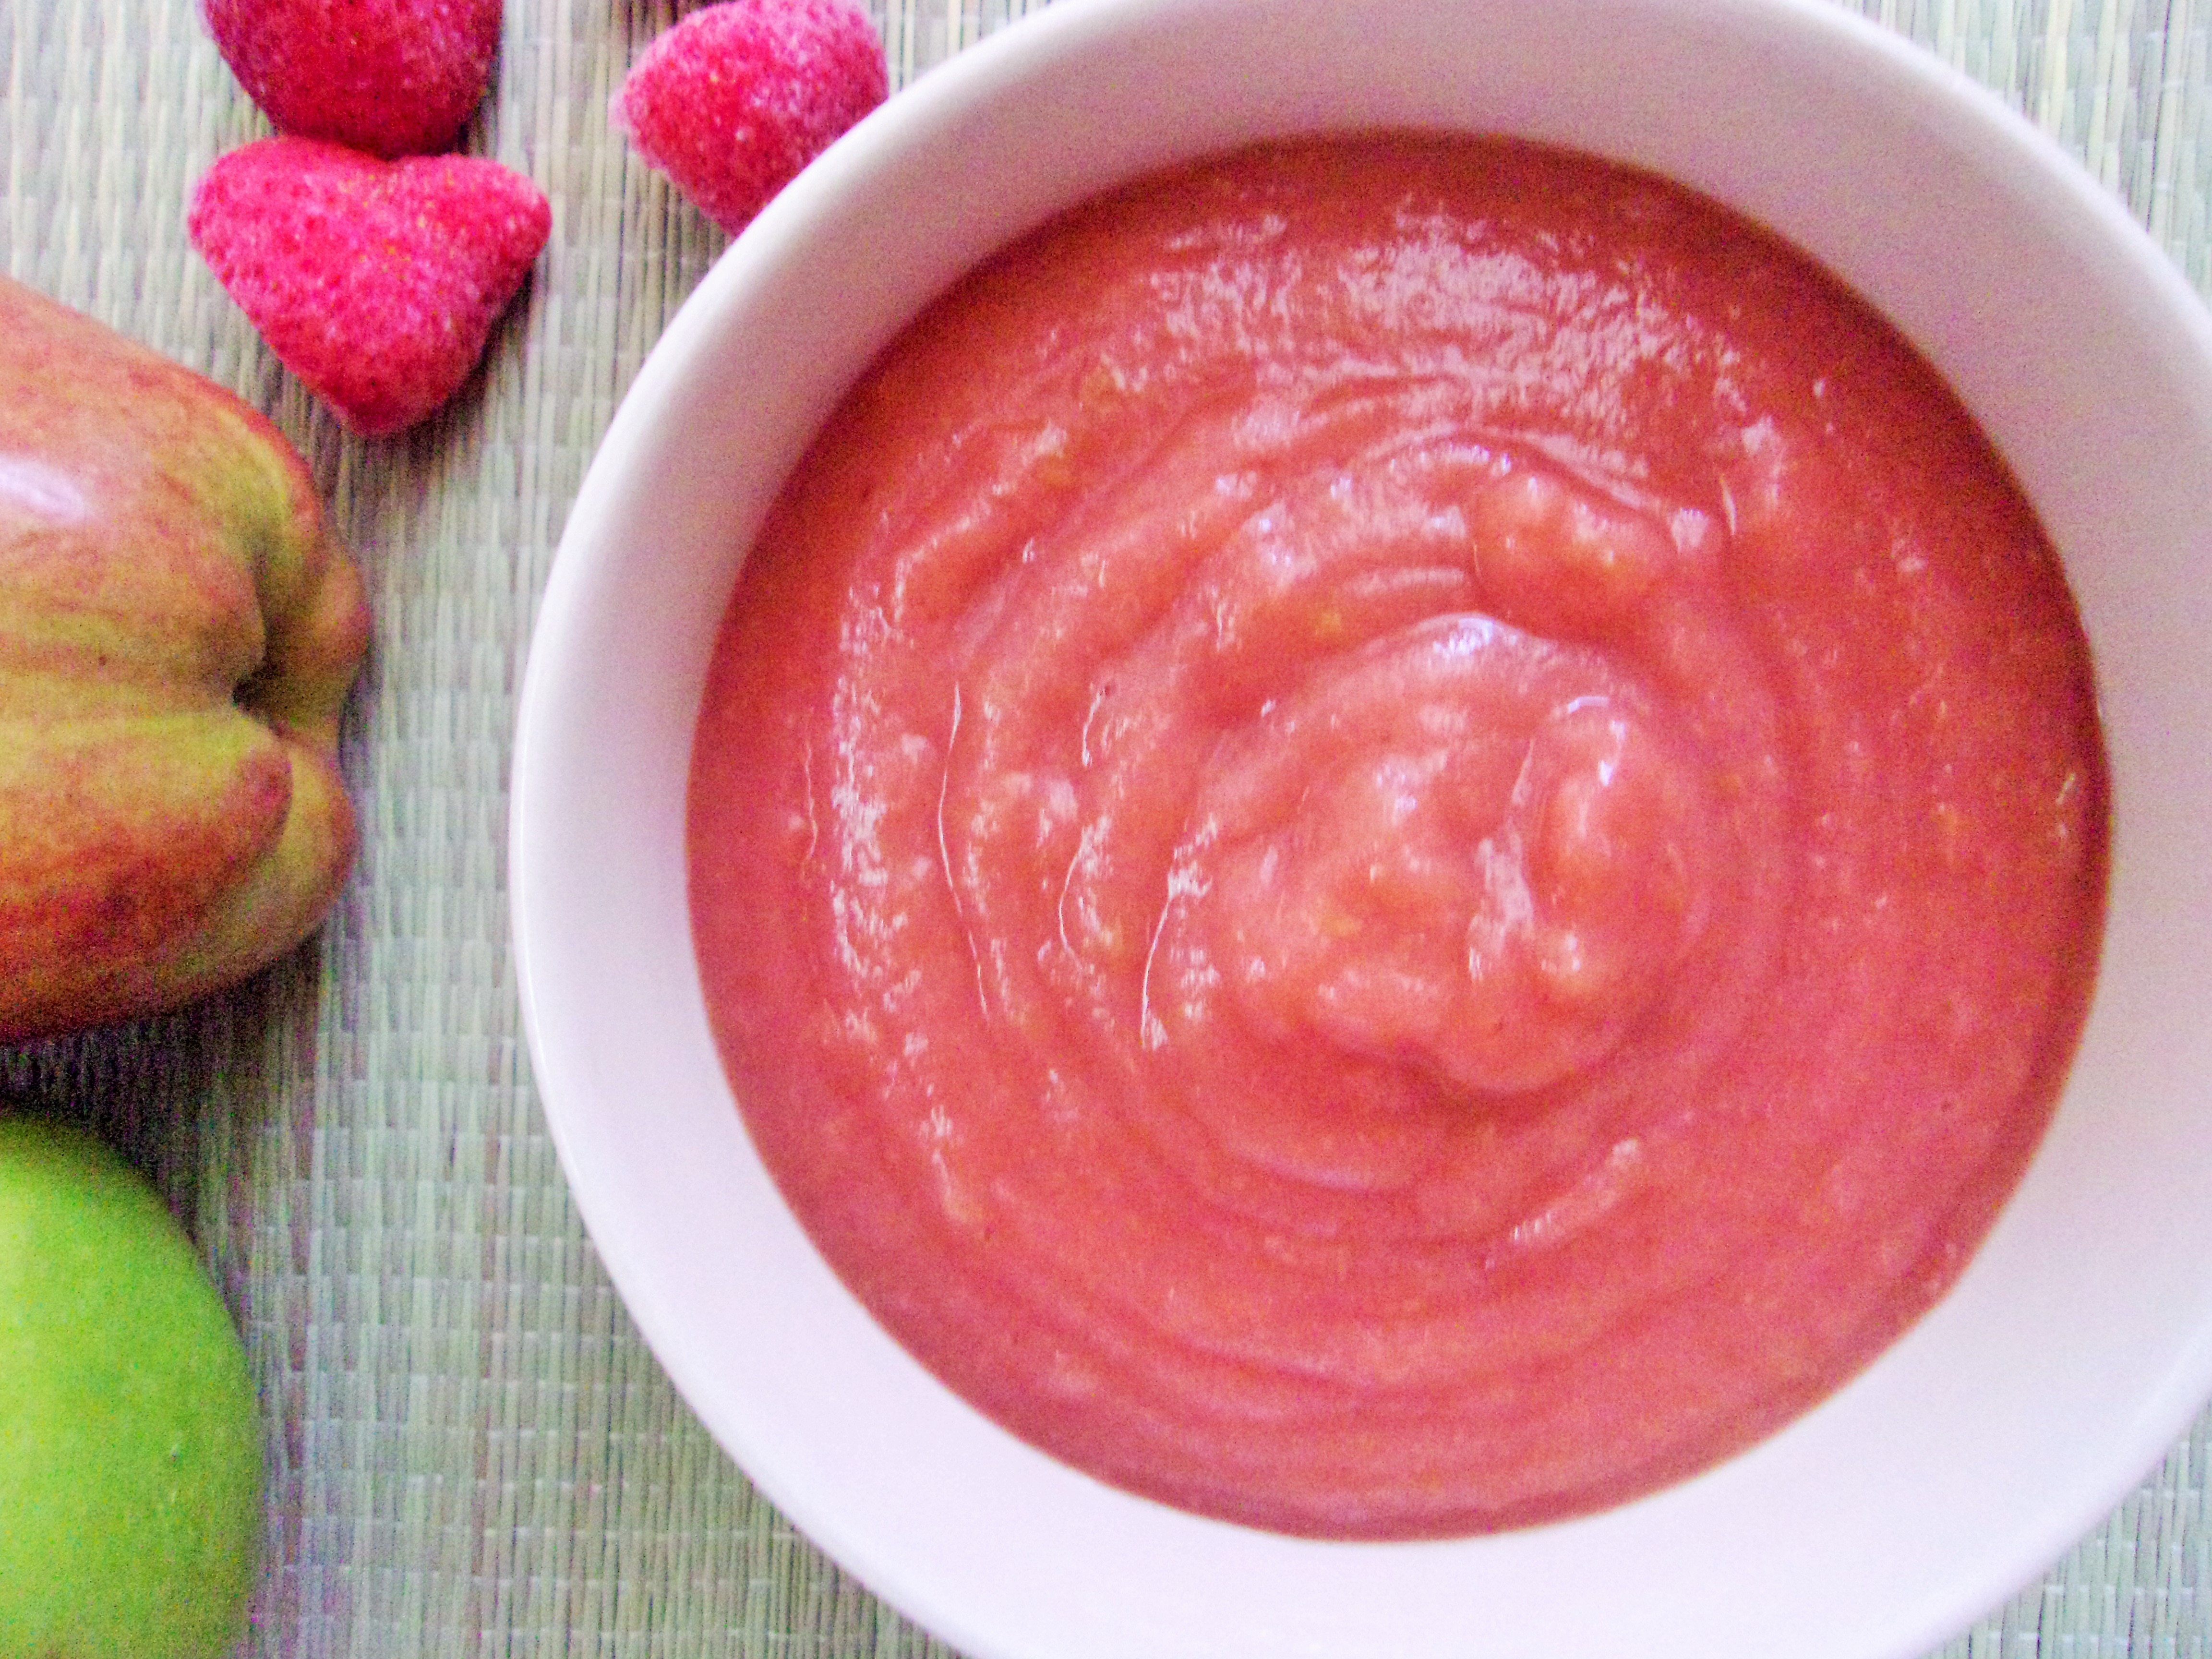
[613,0,889,237]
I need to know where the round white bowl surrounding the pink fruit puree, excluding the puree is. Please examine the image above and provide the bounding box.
[511,0,2212,1659]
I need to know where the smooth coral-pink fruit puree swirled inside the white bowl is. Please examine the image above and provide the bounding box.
[690,137,2106,1538]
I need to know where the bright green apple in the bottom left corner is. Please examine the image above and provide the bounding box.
[0,1117,261,1659]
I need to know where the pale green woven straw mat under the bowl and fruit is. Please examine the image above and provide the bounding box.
[0,0,2212,1659]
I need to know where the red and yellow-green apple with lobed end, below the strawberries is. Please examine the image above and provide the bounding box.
[0,279,370,1042]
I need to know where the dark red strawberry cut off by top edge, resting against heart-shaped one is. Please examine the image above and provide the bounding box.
[201,0,502,155]
